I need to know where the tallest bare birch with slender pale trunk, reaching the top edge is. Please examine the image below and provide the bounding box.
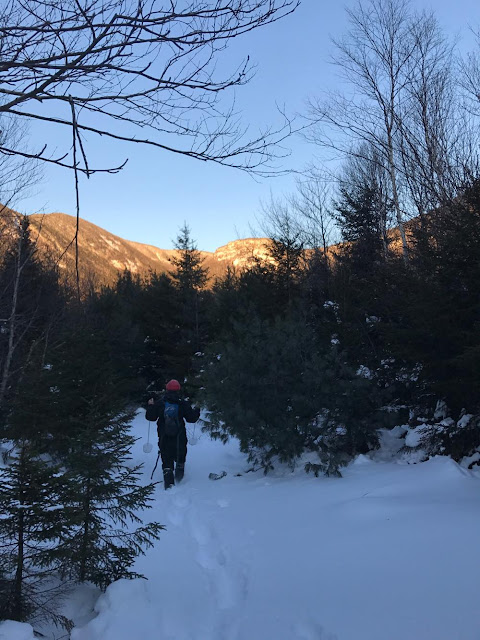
[308,0,415,258]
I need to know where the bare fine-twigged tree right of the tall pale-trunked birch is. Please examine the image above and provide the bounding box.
[398,14,478,215]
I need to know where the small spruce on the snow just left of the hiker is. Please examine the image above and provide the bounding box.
[59,404,164,589]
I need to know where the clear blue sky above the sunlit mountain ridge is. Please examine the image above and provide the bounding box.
[17,0,480,251]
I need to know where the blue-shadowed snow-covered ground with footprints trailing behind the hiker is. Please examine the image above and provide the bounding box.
[0,415,480,640]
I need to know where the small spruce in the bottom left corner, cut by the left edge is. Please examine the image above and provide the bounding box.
[0,439,70,628]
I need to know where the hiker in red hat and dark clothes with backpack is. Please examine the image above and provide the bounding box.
[145,380,200,489]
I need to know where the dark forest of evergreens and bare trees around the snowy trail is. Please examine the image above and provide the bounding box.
[0,0,480,629]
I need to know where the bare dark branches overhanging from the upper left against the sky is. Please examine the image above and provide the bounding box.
[0,0,299,175]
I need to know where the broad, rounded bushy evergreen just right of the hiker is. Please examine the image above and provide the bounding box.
[201,314,382,474]
